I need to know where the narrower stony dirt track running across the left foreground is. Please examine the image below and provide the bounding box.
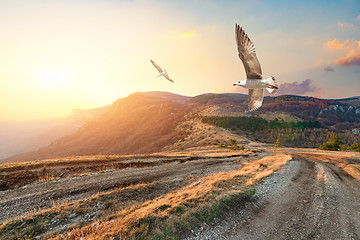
[0,151,269,224]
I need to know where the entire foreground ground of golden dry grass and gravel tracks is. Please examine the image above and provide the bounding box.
[0,146,360,240]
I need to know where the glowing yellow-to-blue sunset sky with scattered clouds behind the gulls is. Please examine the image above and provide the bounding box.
[0,0,360,121]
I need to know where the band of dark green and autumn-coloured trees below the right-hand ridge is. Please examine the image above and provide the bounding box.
[202,116,360,151]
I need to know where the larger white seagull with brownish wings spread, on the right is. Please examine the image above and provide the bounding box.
[234,24,278,112]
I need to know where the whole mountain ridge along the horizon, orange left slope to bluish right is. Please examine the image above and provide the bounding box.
[0,92,360,162]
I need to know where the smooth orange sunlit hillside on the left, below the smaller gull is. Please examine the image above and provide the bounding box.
[6,92,196,161]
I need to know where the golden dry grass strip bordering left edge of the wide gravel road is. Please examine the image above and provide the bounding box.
[40,154,291,239]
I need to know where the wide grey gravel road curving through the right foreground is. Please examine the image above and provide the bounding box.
[187,157,360,239]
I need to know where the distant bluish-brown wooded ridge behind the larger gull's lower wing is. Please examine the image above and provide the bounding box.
[190,94,360,130]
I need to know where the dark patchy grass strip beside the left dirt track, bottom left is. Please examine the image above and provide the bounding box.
[0,179,191,239]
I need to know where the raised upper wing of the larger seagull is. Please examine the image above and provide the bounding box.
[235,24,262,79]
